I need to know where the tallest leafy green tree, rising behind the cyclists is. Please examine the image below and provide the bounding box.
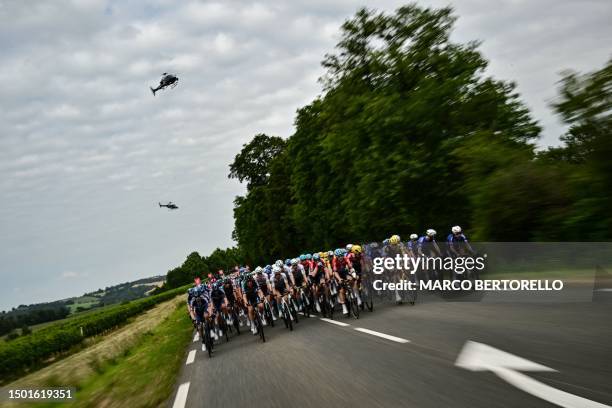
[234,5,540,262]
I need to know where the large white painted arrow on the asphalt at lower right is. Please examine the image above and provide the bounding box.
[455,341,609,408]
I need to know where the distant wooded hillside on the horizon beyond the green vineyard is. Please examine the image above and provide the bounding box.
[0,275,166,339]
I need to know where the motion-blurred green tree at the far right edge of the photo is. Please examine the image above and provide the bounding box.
[540,59,612,236]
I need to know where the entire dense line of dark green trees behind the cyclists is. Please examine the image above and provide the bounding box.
[229,5,612,264]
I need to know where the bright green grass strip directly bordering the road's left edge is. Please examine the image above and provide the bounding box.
[36,303,192,408]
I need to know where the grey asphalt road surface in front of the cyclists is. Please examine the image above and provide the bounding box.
[169,293,612,408]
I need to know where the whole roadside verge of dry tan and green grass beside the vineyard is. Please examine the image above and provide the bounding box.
[7,296,192,407]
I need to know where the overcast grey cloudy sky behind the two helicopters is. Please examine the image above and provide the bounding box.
[0,0,612,310]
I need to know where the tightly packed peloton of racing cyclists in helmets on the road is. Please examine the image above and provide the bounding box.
[187,225,476,350]
